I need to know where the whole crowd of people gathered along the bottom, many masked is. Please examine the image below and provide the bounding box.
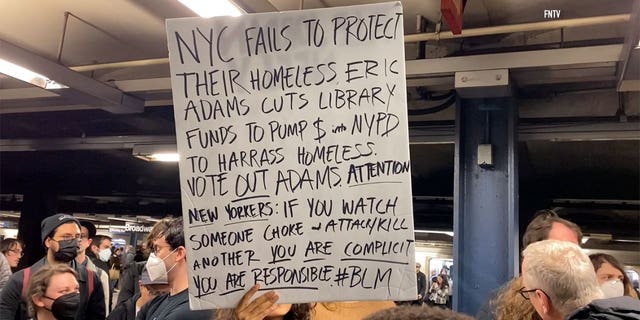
[0,210,640,320]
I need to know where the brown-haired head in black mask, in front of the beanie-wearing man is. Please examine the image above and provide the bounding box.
[27,264,80,320]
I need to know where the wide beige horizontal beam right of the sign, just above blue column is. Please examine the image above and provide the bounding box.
[405,44,622,79]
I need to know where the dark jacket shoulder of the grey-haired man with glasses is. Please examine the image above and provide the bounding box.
[565,296,640,320]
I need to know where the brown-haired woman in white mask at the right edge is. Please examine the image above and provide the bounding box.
[589,253,638,299]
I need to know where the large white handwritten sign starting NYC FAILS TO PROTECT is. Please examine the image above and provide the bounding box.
[167,2,417,309]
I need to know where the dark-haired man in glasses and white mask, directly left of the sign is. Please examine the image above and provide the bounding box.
[136,218,213,320]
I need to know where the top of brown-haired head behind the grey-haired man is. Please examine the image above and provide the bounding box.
[522,210,582,248]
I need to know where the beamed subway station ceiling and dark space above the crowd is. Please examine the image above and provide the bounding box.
[0,0,640,245]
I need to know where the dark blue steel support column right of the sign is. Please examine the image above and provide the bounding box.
[453,98,518,314]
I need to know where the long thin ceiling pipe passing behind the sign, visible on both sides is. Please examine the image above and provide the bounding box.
[69,14,631,72]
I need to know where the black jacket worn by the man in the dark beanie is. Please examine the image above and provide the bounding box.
[0,257,106,320]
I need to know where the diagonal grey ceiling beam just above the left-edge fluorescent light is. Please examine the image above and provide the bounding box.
[0,39,144,113]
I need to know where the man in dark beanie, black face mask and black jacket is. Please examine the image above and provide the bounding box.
[0,214,106,320]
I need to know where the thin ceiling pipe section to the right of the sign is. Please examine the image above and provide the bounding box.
[404,14,631,42]
